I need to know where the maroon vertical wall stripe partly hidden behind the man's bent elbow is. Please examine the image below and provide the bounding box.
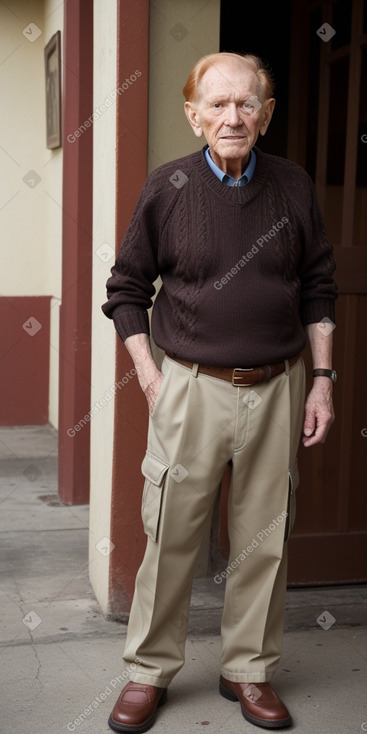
[106,0,149,616]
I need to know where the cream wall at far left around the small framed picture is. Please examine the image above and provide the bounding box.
[0,0,63,425]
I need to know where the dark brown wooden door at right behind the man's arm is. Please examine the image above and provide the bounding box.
[287,0,367,584]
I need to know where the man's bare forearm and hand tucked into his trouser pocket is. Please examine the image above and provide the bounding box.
[125,334,163,414]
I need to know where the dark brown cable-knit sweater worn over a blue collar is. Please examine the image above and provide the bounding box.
[102,148,337,367]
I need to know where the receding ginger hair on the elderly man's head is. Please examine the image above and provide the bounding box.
[183,51,274,102]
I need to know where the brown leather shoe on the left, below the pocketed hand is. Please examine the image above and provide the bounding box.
[108,681,167,734]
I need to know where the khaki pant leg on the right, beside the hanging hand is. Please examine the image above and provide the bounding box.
[221,360,305,683]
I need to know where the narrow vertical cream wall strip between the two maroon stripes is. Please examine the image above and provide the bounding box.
[89,0,117,614]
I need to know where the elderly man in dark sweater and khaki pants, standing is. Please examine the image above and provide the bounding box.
[103,53,336,732]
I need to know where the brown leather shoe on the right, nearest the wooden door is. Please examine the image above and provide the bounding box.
[219,676,292,729]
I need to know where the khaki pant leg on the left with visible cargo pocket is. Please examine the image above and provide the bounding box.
[124,358,237,687]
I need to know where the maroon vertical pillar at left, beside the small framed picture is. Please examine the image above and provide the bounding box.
[59,0,93,504]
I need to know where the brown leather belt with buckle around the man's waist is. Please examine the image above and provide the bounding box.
[166,352,300,387]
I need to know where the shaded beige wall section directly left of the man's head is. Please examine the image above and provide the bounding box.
[148,0,220,171]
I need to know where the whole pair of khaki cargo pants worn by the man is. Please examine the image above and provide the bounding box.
[124,356,305,688]
